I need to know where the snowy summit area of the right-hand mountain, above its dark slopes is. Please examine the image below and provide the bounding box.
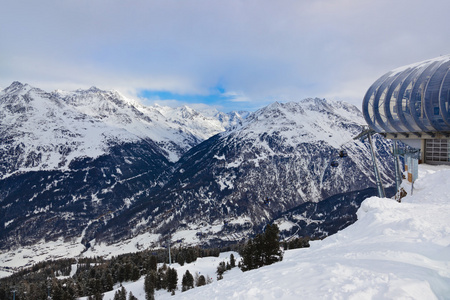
[222,98,365,151]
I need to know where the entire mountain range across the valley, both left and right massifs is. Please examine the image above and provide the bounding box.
[0,82,394,272]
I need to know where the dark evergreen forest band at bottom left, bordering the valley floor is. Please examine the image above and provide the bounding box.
[0,247,220,300]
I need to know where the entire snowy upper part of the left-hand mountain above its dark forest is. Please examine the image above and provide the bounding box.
[0,82,246,178]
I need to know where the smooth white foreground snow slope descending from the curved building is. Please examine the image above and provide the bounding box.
[96,165,450,300]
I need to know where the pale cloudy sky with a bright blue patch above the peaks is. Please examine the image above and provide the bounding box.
[0,0,450,111]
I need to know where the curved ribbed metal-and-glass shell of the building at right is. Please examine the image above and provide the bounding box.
[363,55,450,135]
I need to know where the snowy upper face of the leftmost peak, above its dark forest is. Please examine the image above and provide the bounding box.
[0,82,116,178]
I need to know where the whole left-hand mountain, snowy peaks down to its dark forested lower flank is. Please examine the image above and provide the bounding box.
[0,82,246,248]
